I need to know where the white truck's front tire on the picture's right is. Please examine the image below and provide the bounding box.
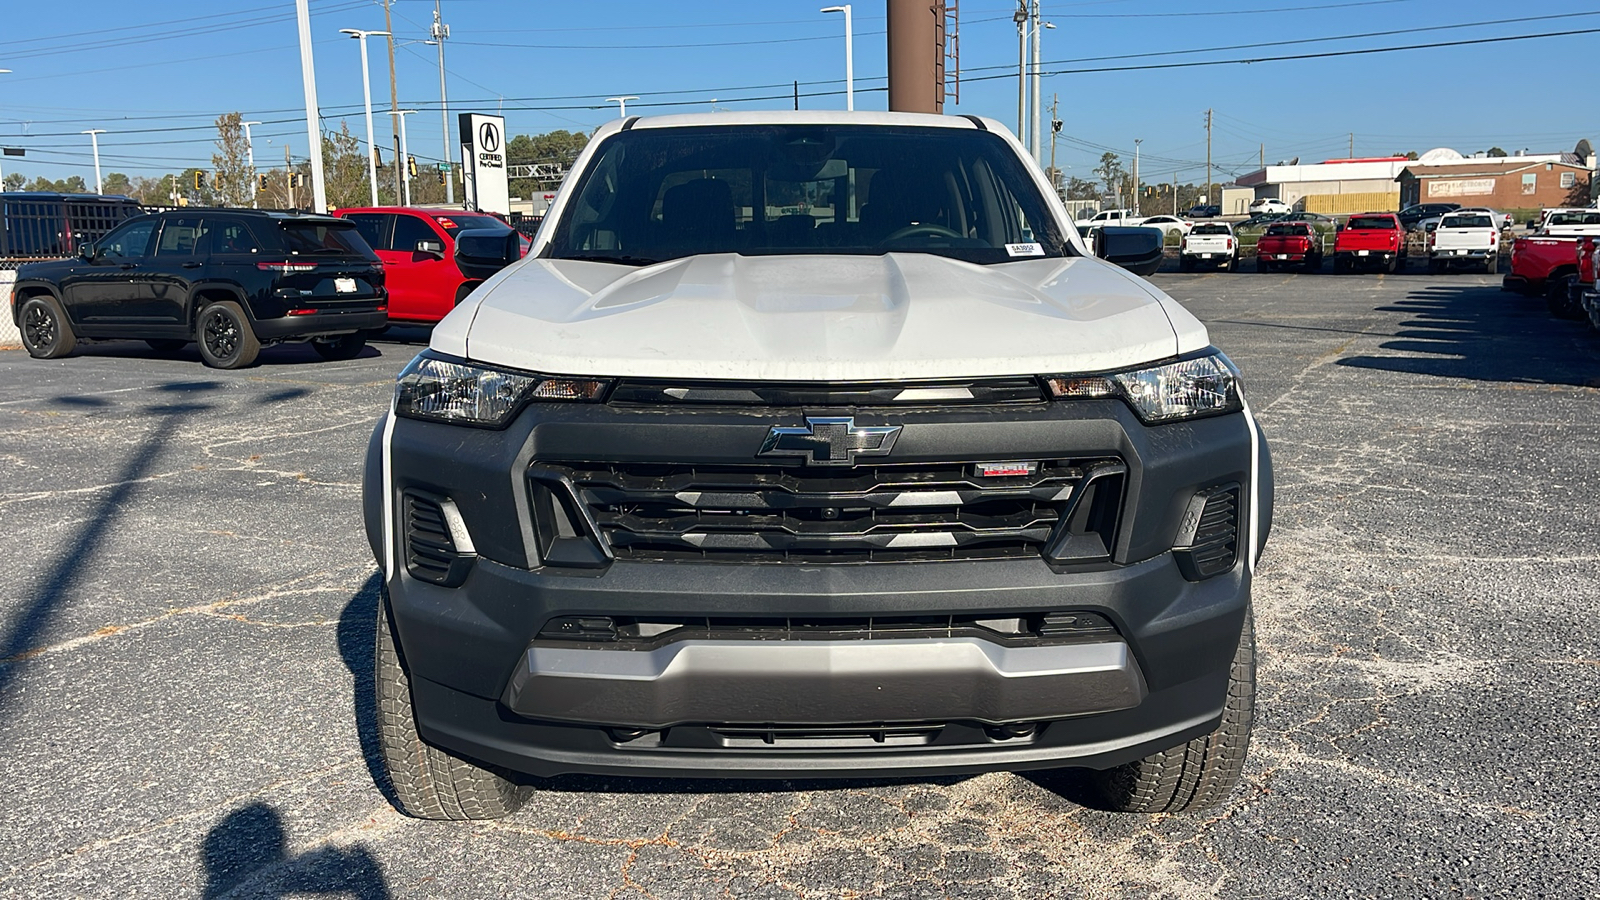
[1090,610,1256,814]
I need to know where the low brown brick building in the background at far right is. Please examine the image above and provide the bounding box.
[1395,157,1592,210]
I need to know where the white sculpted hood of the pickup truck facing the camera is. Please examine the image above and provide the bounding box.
[432,253,1208,381]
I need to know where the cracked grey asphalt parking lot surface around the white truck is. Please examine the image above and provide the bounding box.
[0,269,1600,900]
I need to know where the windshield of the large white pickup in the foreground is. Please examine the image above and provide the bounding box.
[550,125,1067,264]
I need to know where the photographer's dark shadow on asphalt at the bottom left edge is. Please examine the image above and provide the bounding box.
[200,802,389,900]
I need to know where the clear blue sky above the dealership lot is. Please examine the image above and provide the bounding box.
[0,0,1600,183]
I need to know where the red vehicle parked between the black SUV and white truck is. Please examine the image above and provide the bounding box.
[334,207,530,325]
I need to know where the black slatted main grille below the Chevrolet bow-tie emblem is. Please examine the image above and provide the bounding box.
[546,460,1126,564]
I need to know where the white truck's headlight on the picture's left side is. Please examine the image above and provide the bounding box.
[395,354,606,428]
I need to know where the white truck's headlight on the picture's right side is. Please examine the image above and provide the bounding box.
[1045,352,1243,424]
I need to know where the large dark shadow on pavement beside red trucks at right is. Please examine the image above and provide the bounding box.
[1338,283,1600,386]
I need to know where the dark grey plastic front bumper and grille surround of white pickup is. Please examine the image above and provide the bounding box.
[366,400,1270,777]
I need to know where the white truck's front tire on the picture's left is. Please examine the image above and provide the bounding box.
[373,588,533,820]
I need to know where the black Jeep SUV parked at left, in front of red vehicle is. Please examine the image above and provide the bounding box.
[11,210,389,368]
